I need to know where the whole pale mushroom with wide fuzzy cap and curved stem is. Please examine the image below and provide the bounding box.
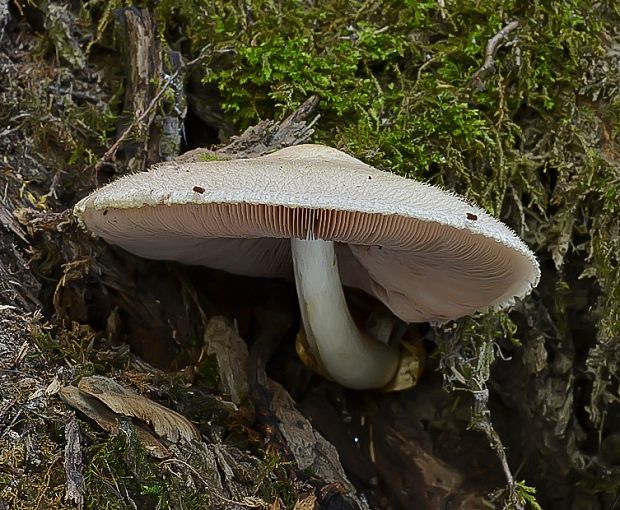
[74,145,540,389]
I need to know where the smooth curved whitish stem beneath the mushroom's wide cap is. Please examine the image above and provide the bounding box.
[291,239,399,390]
